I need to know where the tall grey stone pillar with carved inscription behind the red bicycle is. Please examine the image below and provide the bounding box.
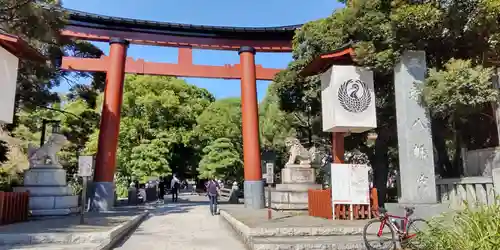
[394,51,437,204]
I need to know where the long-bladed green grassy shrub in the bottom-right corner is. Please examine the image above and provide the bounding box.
[419,202,500,250]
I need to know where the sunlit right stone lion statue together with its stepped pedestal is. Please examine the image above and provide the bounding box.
[271,138,321,210]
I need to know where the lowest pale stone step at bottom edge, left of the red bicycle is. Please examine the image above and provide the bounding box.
[251,235,367,250]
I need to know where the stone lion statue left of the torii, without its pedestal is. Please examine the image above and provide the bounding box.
[28,134,68,167]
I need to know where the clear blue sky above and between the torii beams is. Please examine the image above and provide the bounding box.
[60,0,342,100]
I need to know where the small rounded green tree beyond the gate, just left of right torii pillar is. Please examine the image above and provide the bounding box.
[198,138,243,181]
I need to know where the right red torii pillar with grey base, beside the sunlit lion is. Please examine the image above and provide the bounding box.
[238,46,265,209]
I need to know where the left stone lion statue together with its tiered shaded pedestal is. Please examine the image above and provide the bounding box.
[15,133,78,216]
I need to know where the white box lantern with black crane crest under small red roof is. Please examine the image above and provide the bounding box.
[321,65,377,133]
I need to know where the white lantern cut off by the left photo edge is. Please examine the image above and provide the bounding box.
[0,46,19,124]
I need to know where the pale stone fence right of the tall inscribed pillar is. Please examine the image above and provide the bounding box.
[436,169,500,209]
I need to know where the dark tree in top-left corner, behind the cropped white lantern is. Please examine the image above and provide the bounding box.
[0,0,102,111]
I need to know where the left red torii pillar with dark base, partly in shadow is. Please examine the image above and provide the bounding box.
[92,38,129,211]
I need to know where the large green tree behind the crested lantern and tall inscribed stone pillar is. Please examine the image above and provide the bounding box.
[275,0,500,203]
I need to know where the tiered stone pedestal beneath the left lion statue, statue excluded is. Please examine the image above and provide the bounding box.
[14,165,78,216]
